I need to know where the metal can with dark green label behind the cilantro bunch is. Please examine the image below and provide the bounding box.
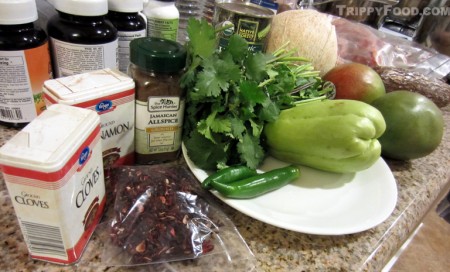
[213,0,275,52]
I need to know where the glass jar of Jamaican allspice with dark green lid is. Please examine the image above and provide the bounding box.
[128,37,186,164]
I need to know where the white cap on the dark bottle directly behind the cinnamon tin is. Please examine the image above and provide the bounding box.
[53,0,108,16]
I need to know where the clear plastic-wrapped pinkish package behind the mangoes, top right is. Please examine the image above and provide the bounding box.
[333,17,450,78]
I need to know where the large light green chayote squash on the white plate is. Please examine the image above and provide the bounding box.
[264,99,386,173]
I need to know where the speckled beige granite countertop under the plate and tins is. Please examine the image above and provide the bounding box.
[0,107,450,271]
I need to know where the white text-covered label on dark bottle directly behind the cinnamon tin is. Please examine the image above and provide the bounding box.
[50,38,119,77]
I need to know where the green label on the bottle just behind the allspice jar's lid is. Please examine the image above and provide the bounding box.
[147,18,180,41]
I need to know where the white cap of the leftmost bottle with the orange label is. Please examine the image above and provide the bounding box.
[0,0,38,25]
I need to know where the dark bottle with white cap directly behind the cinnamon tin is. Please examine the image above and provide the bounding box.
[47,0,118,77]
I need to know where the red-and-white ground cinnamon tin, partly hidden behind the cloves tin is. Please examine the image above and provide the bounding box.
[43,68,135,171]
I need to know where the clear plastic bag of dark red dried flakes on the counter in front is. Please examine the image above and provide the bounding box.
[80,163,256,271]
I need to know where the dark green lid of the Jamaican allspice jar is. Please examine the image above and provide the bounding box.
[130,37,186,73]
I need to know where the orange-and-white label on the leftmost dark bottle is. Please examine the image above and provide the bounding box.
[0,43,51,123]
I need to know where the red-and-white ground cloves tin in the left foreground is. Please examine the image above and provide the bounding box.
[0,104,105,264]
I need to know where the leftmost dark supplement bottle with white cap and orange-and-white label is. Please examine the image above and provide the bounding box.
[0,0,52,128]
